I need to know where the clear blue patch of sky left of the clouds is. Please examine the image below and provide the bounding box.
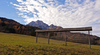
[0,0,25,24]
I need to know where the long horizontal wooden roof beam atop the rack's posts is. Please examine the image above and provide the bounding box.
[35,27,92,32]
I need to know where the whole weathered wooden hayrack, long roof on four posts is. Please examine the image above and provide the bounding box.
[35,27,92,48]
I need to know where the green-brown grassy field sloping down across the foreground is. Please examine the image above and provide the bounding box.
[0,33,100,55]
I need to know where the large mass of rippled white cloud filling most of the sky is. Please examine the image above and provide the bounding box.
[11,0,100,36]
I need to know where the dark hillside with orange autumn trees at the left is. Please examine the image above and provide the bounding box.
[0,17,40,35]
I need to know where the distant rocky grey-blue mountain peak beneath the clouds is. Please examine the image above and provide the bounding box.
[27,20,62,29]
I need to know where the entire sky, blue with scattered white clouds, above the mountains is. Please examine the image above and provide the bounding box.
[0,0,100,36]
